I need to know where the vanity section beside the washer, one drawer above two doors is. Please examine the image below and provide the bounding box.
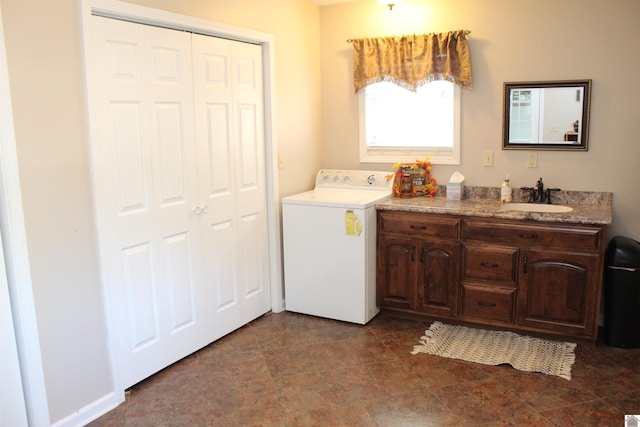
[377,212,460,317]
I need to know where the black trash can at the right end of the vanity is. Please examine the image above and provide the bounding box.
[604,236,640,348]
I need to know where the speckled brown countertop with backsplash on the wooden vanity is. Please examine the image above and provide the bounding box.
[376,187,613,225]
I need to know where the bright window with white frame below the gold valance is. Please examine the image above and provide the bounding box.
[359,80,460,165]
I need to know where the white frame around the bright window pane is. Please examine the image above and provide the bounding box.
[358,83,461,165]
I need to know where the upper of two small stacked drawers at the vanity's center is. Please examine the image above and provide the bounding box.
[462,243,518,286]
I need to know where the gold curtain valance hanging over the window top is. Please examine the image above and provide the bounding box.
[350,30,472,92]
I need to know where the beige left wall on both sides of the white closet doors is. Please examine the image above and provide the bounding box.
[0,0,321,422]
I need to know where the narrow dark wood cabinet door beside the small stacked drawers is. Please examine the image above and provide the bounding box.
[417,240,460,316]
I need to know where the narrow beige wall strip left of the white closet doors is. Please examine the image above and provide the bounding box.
[0,0,113,421]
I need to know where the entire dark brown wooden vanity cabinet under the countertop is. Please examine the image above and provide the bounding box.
[377,211,605,341]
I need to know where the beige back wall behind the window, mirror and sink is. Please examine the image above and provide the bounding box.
[320,0,640,240]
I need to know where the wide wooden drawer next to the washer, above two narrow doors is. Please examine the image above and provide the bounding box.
[378,212,460,239]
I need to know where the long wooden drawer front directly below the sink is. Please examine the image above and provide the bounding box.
[463,221,602,251]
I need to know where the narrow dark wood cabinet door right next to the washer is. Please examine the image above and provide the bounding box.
[376,237,418,309]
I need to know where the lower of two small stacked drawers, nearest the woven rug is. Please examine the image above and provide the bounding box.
[462,284,516,323]
